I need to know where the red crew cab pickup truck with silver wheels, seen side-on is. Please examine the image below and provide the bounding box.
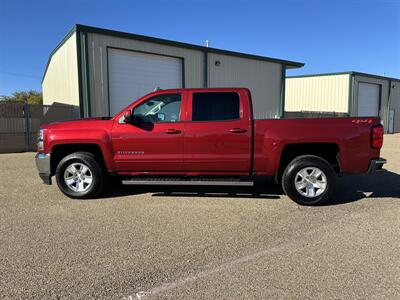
[36,88,386,205]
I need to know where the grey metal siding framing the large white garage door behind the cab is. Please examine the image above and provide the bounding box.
[88,33,204,116]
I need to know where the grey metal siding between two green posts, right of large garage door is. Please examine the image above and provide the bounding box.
[208,53,282,119]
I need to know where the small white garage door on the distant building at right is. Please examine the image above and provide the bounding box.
[358,82,381,117]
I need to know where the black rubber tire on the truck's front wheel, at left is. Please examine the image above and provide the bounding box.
[56,152,105,199]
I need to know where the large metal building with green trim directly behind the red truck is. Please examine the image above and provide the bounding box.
[42,25,304,119]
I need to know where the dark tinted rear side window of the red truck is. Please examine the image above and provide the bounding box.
[192,92,240,121]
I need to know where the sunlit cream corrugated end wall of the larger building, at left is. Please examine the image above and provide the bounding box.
[42,33,79,106]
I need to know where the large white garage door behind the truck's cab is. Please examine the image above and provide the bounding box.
[108,49,182,115]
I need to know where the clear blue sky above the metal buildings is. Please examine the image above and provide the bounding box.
[0,0,400,95]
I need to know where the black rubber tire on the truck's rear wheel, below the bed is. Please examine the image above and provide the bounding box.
[282,155,336,205]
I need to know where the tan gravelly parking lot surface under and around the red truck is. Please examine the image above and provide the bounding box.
[0,134,400,299]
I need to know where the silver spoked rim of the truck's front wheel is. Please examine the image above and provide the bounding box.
[64,163,93,192]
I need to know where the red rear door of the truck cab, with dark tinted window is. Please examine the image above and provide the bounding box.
[184,90,252,173]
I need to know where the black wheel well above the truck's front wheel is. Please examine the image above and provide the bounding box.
[50,144,105,175]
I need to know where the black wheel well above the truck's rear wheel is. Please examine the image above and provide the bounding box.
[278,143,340,176]
